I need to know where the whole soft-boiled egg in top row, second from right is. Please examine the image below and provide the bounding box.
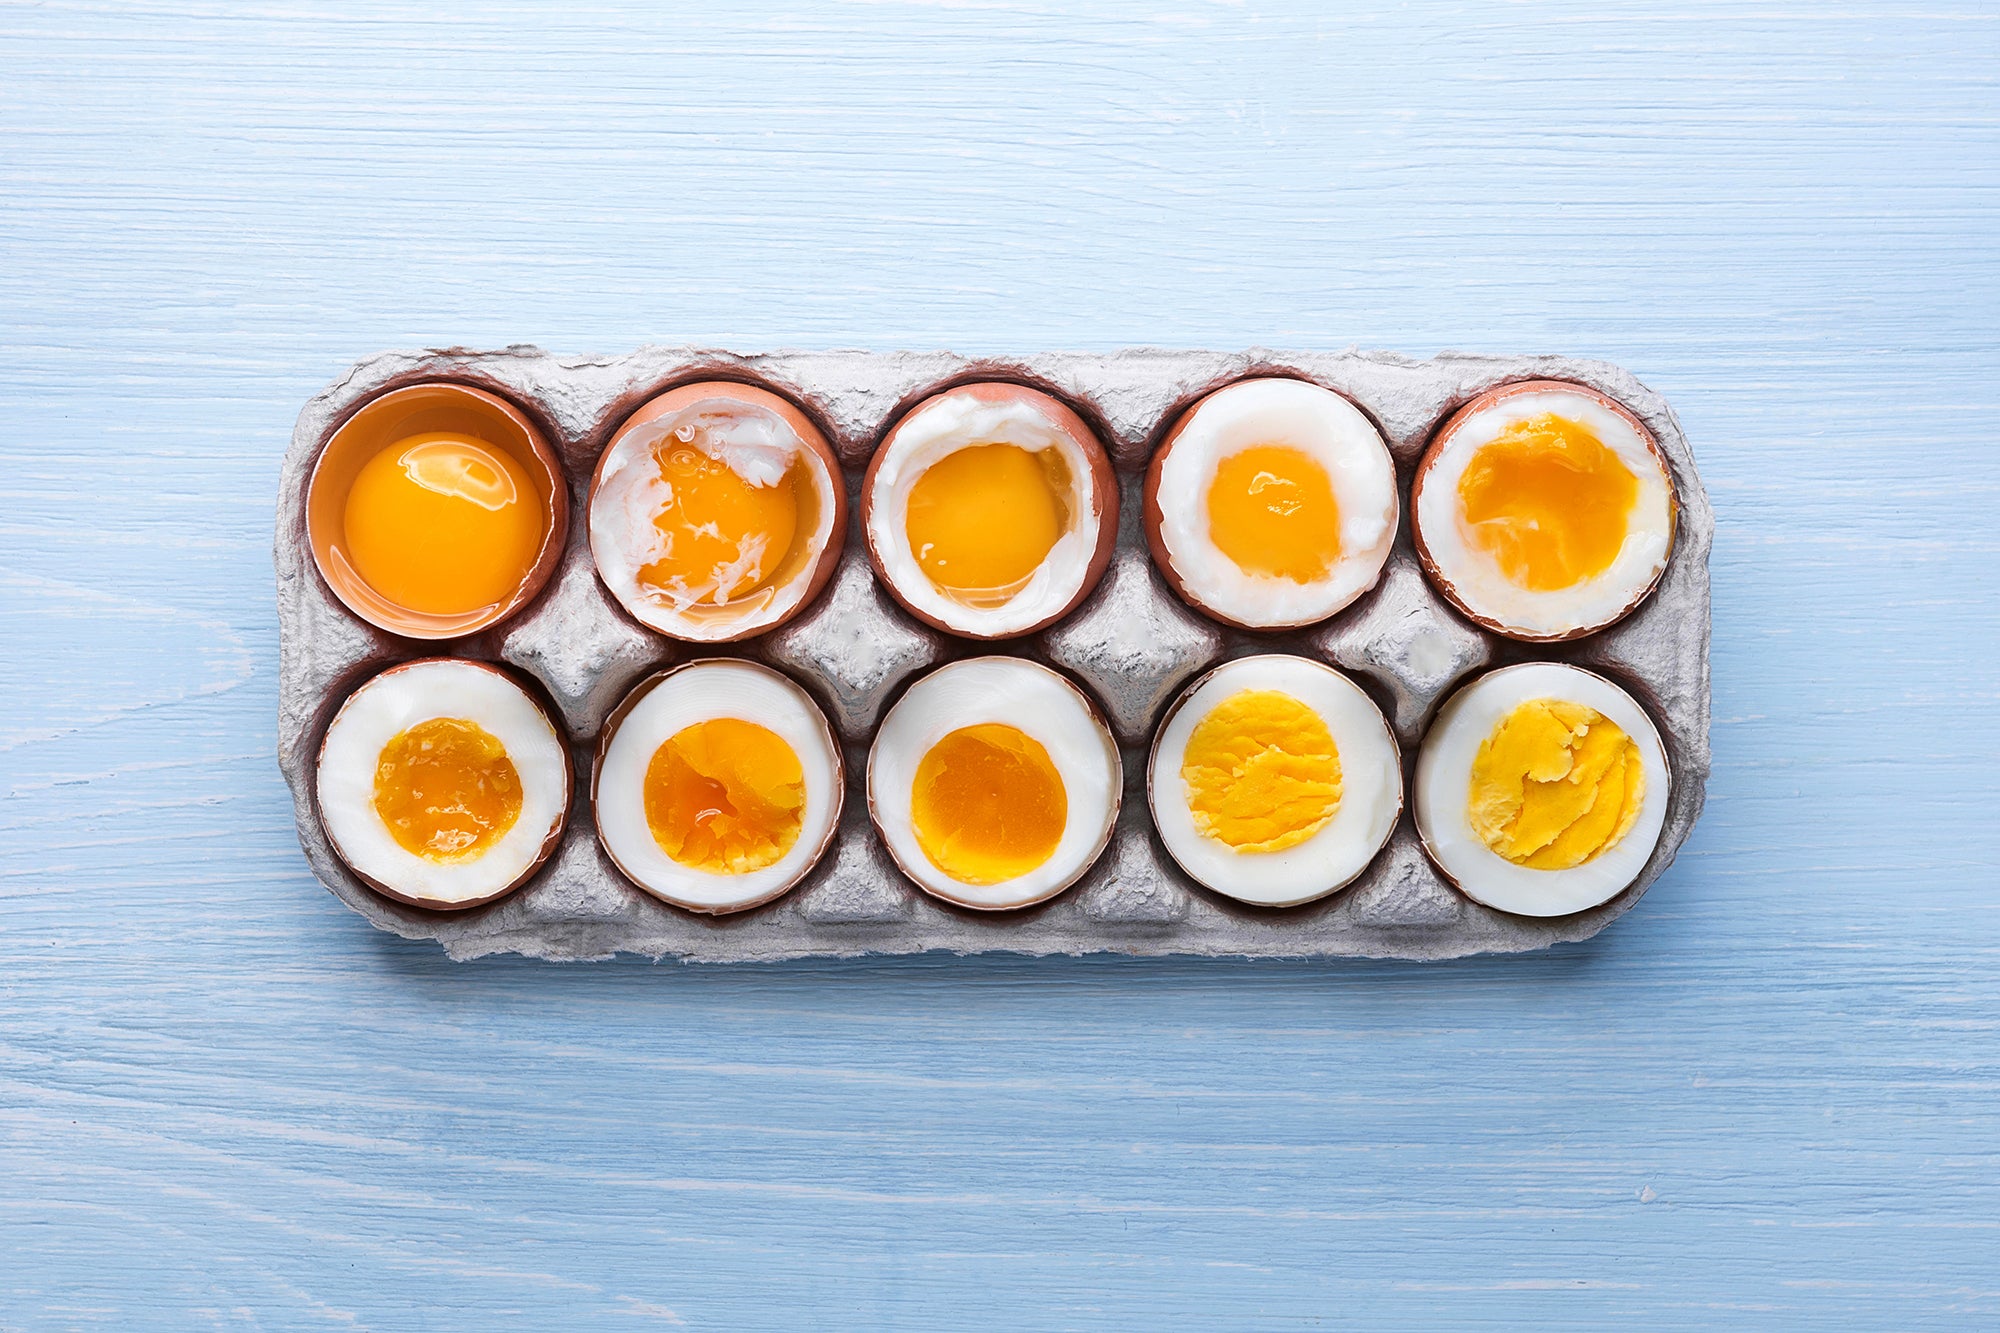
[1146,378,1396,630]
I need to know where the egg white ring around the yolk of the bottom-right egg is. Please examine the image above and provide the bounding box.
[1416,662,1672,917]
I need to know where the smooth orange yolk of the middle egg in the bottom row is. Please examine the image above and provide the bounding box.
[910,723,1070,885]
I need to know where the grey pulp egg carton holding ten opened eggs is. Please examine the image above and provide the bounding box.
[276,346,1714,961]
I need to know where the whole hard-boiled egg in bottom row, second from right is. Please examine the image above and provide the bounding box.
[1146,654,1402,907]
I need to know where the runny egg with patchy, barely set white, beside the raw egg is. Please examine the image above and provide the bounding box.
[590,380,846,642]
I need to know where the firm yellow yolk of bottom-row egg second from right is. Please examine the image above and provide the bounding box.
[1180,691,1340,853]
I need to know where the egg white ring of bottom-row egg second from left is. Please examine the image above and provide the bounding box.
[592,658,842,913]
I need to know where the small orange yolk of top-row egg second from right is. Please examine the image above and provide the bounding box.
[1208,444,1340,582]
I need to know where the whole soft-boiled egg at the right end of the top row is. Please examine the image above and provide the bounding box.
[1410,380,1678,642]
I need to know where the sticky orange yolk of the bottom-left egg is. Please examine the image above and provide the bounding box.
[374,717,520,863]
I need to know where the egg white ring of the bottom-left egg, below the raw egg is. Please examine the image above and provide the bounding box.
[316,658,570,907]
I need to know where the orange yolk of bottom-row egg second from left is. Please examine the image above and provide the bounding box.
[646,717,806,875]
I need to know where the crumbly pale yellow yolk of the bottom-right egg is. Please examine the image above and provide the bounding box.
[1468,699,1646,871]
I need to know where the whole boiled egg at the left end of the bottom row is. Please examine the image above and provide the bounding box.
[316,658,570,909]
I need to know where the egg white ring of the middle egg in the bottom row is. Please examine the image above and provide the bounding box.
[868,656,1122,909]
